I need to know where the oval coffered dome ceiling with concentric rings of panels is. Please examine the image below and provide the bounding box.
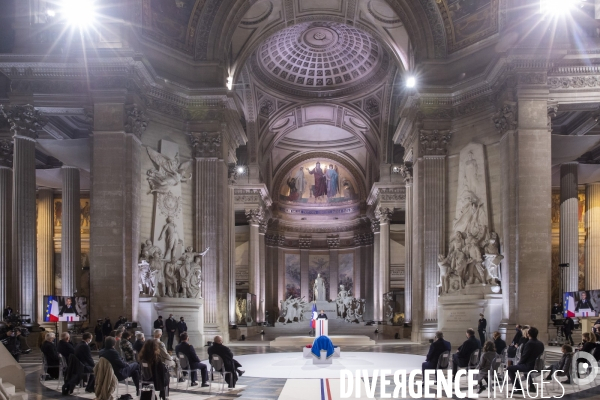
[253,22,390,95]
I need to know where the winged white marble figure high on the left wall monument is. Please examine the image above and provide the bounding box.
[146,147,192,194]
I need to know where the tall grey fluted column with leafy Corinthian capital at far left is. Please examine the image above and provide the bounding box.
[1,105,46,318]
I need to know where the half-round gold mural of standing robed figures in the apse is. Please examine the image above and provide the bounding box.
[279,159,358,205]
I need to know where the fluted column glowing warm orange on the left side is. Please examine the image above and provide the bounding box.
[37,189,54,321]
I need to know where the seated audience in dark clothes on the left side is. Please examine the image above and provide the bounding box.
[40,314,244,399]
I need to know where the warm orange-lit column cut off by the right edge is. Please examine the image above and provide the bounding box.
[584,183,600,289]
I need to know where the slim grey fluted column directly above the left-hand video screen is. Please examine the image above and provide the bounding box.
[60,166,81,296]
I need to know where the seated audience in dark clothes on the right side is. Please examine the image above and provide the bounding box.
[422,322,600,393]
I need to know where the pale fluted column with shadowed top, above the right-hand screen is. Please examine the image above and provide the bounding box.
[560,162,579,293]
